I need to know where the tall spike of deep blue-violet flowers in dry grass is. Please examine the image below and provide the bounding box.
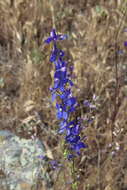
[45,29,86,159]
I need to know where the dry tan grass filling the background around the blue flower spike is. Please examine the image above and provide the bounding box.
[0,0,127,190]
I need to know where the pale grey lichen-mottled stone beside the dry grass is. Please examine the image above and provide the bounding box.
[0,130,51,190]
